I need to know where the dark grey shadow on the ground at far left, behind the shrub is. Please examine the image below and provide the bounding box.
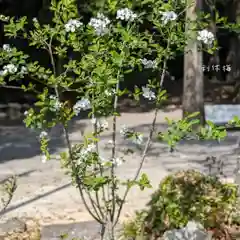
[0,118,85,163]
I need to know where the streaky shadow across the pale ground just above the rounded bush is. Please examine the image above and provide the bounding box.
[99,124,240,177]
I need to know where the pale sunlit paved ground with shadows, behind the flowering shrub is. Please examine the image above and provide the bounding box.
[0,109,240,239]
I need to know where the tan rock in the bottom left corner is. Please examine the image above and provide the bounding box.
[0,218,27,237]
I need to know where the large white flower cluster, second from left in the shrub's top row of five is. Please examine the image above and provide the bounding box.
[89,13,110,36]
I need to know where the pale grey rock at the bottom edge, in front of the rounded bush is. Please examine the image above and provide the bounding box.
[163,222,212,240]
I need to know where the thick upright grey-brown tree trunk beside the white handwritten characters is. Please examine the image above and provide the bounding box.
[182,0,204,124]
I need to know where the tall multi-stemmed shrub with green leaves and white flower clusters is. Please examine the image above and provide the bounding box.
[0,0,238,239]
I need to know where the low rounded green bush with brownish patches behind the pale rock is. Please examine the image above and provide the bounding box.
[122,170,238,239]
